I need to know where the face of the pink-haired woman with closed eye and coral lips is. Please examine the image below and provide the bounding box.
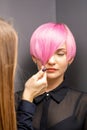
[32,44,72,79]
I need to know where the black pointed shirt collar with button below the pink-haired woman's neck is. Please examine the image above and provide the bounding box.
[34,81,68,104]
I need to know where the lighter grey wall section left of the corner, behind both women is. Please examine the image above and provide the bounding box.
[0,0,56,91]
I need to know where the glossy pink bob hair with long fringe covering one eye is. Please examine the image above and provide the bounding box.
[30,23,76,65]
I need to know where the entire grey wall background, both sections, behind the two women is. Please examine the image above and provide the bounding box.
[0,0,87,92]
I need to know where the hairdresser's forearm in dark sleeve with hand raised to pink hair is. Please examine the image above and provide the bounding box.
[17,70,47,130]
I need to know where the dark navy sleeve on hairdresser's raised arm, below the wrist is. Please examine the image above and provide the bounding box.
[17,100,36,130]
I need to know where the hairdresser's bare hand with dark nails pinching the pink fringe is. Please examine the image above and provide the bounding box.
[22,70,47,102]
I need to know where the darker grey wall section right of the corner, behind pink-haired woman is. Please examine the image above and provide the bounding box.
[56,0,87,91]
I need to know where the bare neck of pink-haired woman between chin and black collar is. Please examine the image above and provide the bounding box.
[46,78,63,92]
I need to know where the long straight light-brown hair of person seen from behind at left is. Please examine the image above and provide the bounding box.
[0,19,18,130]
